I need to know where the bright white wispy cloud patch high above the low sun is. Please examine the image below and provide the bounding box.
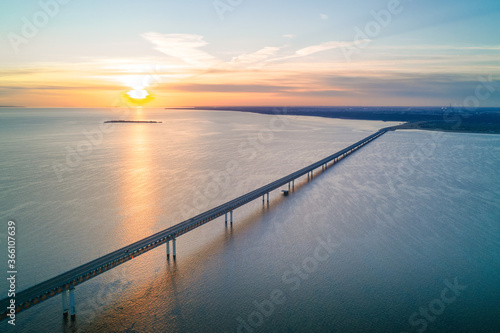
[141,32,219,67]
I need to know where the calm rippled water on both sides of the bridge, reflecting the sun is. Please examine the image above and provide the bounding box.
[0,109,500,332]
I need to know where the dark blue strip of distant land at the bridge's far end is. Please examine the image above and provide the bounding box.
[189,106,500,134]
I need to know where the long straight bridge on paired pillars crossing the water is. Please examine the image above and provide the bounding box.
[0,127,395,321]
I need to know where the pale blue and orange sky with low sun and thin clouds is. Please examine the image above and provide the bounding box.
[0,0,500,107]
